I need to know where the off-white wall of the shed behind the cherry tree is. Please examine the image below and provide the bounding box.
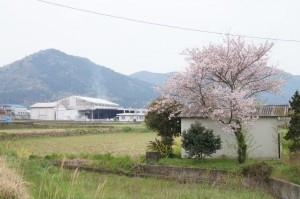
[181,117,279,159]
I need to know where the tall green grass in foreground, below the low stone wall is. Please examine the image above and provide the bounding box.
[9,159,272,199]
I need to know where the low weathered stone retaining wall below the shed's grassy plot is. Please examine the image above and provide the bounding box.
[139,164,300,199]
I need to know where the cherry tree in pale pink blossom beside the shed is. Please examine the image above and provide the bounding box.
[160,36,284,163]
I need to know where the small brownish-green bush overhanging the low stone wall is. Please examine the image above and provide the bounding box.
[242,162,273,182]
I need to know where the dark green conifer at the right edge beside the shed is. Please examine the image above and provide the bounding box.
[284,90,300,152]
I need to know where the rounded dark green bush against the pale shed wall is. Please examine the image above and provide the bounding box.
[182,122,221,159]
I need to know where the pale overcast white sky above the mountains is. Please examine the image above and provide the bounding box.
[0,0,300,75]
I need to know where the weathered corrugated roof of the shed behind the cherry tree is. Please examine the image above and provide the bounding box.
[180,105,289,118]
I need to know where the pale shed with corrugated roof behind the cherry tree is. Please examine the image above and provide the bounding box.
[180,105,289,159]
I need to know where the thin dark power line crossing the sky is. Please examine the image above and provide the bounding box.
[36,0,300,43]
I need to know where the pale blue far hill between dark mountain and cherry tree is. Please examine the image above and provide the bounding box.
[130,71,176,86]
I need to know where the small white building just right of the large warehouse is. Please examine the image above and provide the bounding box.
[117,109,147,122]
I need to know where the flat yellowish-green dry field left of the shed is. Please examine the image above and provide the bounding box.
[0,132,156,157]
